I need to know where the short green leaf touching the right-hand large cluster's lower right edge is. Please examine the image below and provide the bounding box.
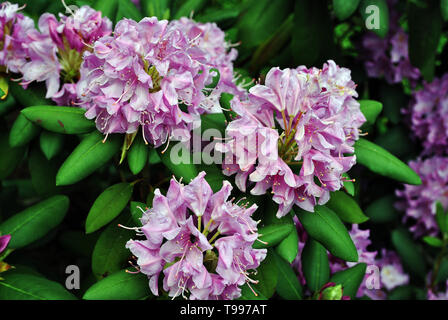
[325,191,369,224]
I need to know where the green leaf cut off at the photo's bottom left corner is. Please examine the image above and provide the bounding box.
[0,270,76,300]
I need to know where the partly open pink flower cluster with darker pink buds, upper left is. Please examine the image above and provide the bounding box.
[21,6,112,105]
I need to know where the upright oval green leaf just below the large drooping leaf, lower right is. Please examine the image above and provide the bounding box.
[300,239,330,292]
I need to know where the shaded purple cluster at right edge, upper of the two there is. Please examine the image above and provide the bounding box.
[405,74,448,155]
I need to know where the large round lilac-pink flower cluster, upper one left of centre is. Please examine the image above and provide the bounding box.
[77,17,240,147]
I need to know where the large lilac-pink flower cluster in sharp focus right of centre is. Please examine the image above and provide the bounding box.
[216,60,365,217]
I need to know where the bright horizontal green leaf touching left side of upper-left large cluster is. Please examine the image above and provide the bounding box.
[21,106,95,134]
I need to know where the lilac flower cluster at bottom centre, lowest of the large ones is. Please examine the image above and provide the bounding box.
[126,172,266,300]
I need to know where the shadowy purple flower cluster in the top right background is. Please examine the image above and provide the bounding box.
[362,0,420,84]
